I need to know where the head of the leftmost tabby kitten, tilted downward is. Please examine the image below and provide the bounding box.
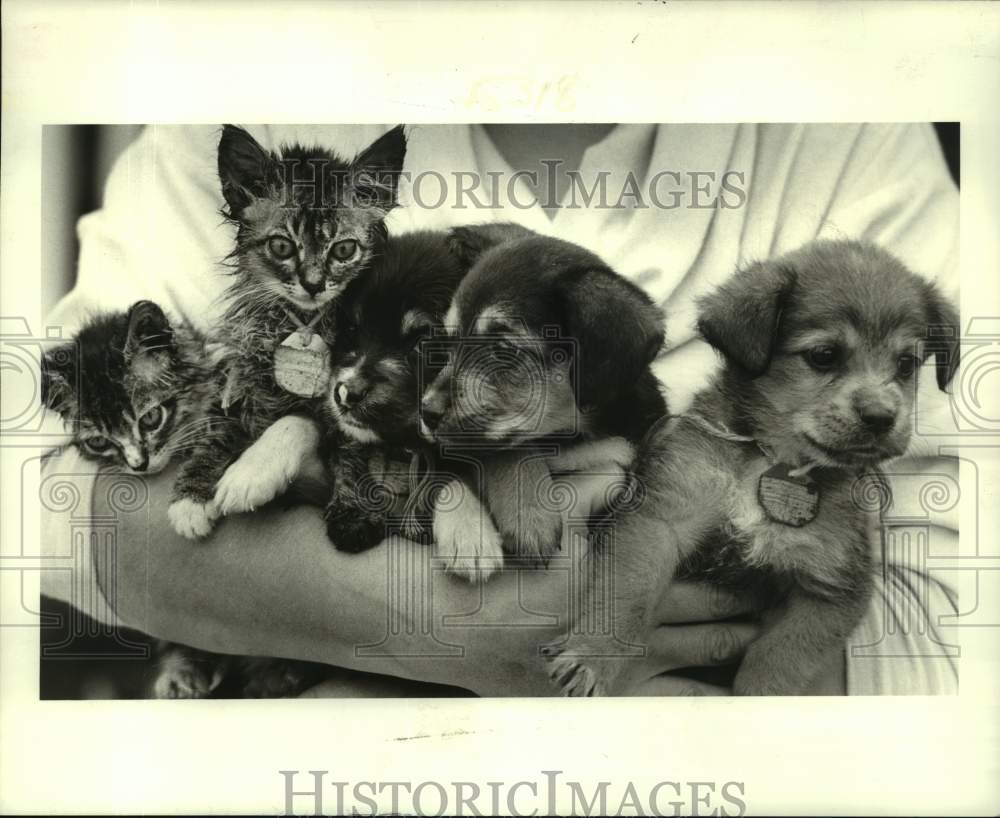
[42,301,220,474]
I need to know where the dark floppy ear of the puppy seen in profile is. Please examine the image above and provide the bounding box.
[563,267,664,404]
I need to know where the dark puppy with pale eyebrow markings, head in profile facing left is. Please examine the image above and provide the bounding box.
[421,225,666,581]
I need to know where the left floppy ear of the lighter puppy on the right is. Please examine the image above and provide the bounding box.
[698,262,796,377]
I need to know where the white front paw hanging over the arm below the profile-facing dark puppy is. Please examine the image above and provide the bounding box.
[434,480,504,582]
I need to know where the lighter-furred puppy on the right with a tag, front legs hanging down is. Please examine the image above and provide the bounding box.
[543,241,958,696]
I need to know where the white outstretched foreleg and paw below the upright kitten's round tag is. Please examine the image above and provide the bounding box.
[215,415,319,515]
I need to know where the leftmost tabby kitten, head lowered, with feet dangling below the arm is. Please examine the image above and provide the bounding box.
[42,301,326,698]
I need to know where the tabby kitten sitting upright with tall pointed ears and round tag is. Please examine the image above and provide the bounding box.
[169,125,406,538]
